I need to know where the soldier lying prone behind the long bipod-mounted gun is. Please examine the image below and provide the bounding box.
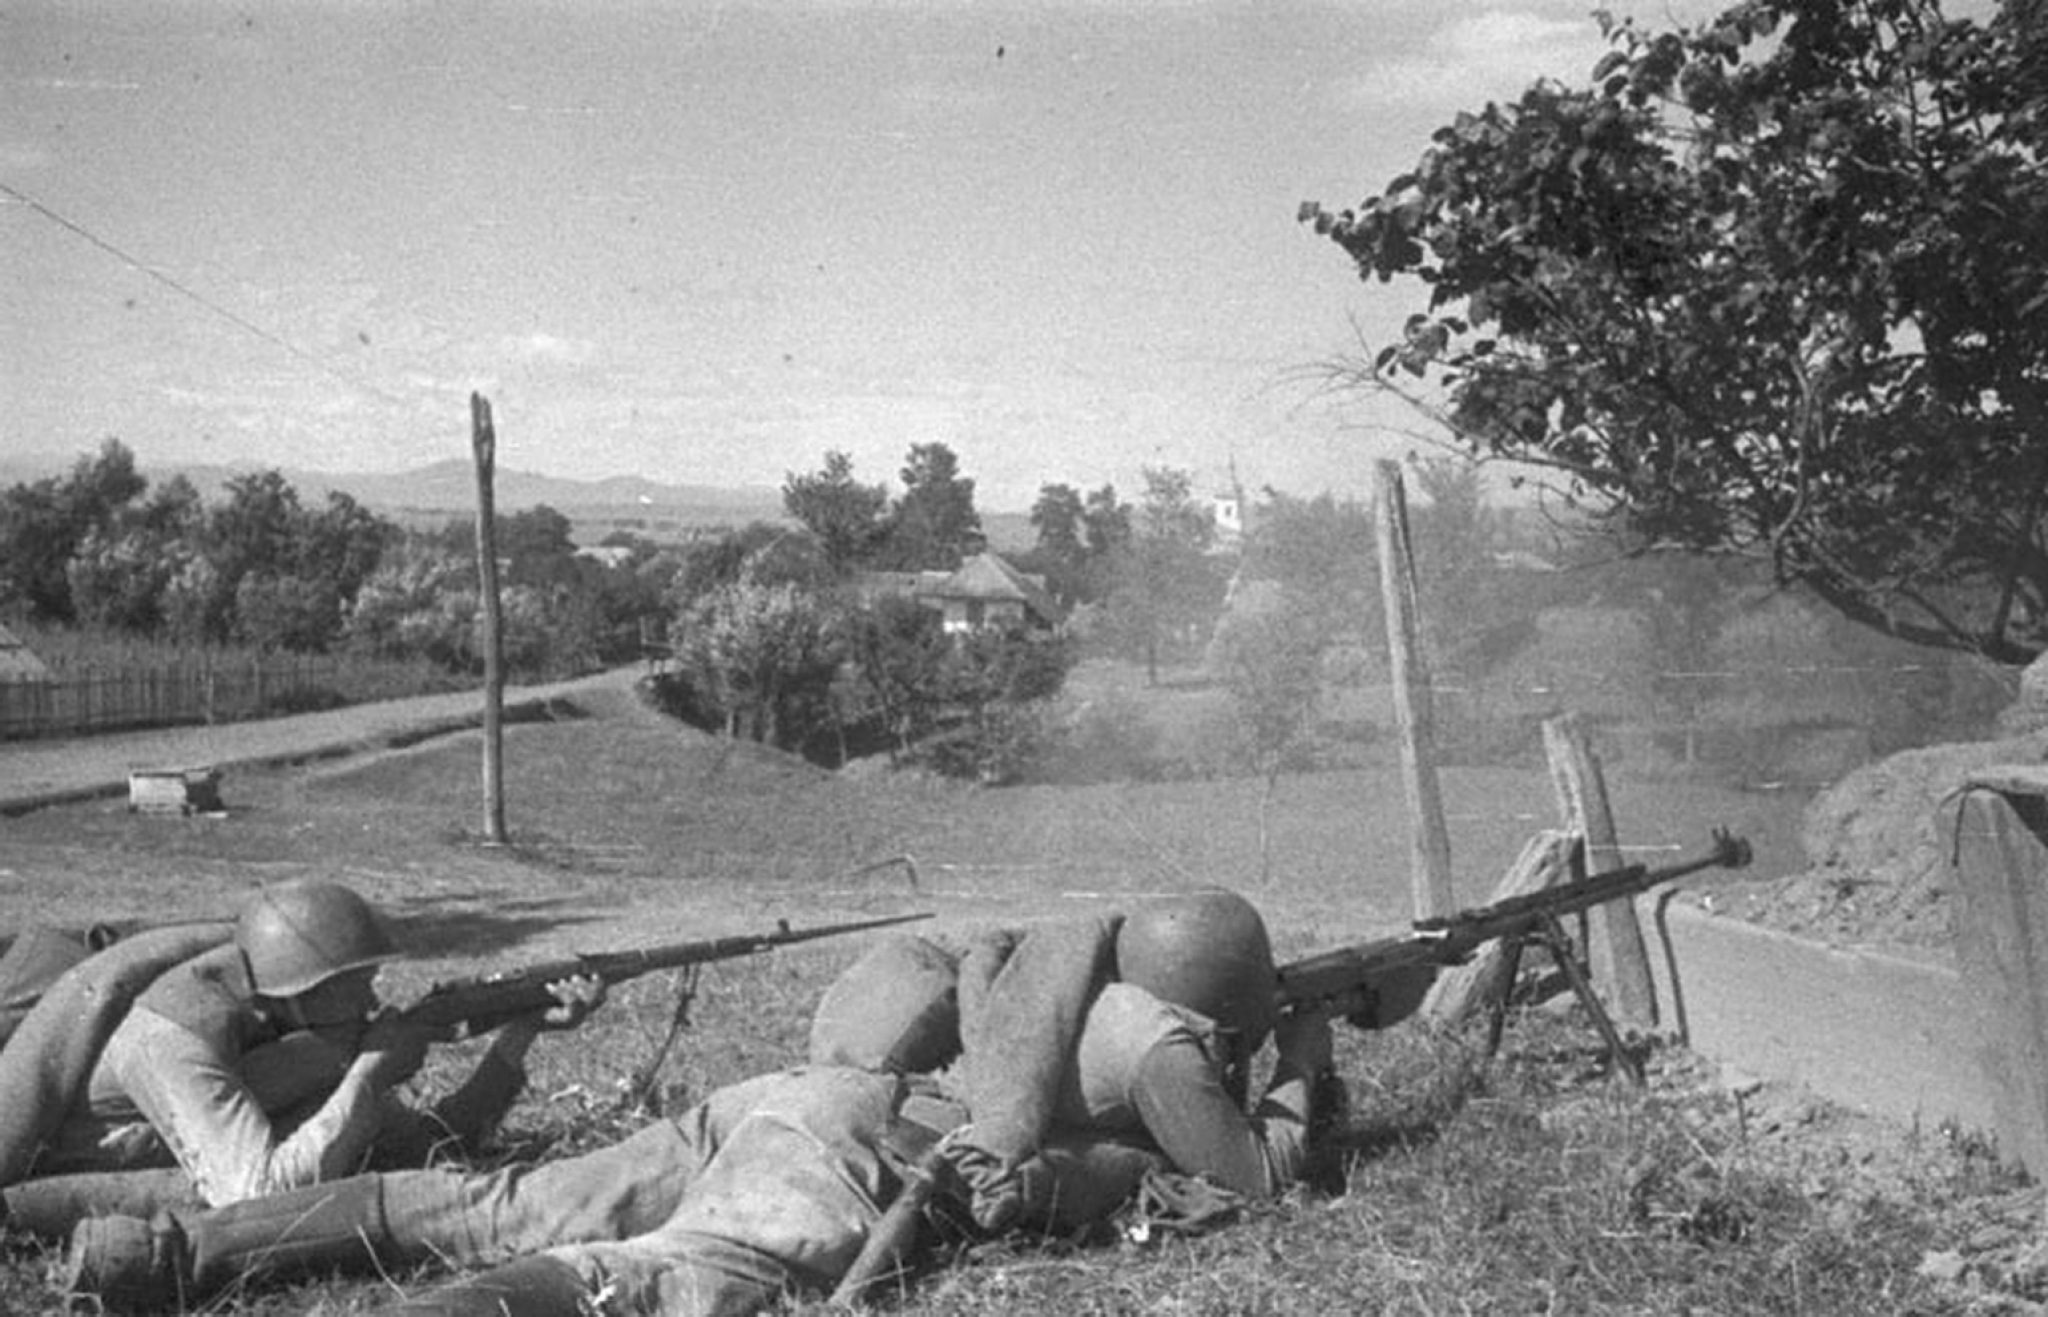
[68,891,1331,1317]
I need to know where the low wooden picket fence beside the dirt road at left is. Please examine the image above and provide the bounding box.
[0,653,338,739]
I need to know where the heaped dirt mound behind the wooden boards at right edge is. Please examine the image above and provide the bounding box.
[1733,729,2048,952]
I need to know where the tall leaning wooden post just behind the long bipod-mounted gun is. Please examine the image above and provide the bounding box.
[1372,461,1456,920]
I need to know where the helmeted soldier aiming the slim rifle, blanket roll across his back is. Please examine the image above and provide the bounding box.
[0,881,602,1237]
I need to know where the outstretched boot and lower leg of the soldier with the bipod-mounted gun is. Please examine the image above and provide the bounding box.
[63,1176,414,1311]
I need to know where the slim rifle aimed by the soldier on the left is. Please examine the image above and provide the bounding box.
[395,914,932,1038]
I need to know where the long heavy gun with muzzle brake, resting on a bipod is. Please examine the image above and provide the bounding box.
[1278,832,1751,1028]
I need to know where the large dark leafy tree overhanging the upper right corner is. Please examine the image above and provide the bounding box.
[1300,0,2048,662]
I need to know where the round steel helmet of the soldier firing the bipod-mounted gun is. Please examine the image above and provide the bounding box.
[1116,887,1280,1053]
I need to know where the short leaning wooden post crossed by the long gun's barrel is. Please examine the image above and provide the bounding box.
[1542,713,1657,1030]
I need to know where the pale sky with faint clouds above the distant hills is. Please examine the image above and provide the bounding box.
[0,0,1712,510]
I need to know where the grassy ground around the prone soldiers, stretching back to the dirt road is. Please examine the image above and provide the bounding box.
[0,690,2023,1315]
